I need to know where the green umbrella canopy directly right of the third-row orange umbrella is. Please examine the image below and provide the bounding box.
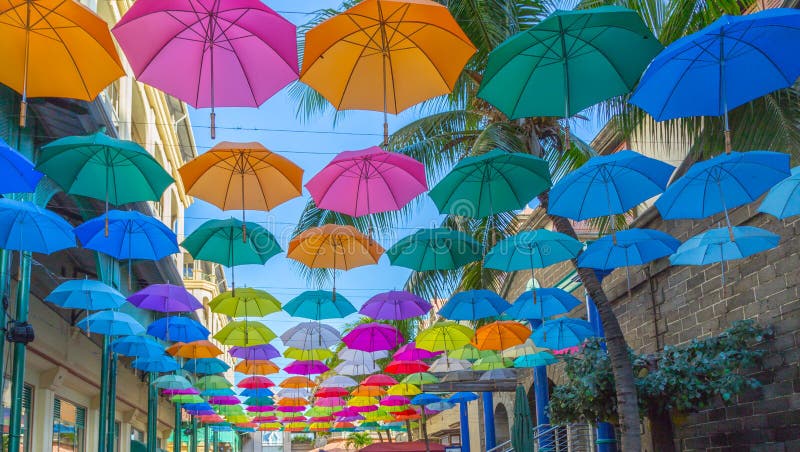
[386,228,483,271]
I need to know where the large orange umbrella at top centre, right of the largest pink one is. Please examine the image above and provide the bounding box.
[300,0,475,144]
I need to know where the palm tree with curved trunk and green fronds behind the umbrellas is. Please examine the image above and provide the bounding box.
[293,0,800,450]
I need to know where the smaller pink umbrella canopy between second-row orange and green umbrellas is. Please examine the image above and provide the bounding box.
[306,146,428,217]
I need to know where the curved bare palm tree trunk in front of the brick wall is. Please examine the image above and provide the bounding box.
[539,191,642,451]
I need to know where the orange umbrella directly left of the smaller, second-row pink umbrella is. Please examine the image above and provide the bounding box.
[178,141,303,237]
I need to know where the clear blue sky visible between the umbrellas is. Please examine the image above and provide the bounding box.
[186,0,595,378]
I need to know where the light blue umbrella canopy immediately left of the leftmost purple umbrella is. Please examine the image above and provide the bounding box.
[44,279,125,311]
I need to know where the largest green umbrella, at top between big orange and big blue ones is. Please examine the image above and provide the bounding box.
[478,6,664,146]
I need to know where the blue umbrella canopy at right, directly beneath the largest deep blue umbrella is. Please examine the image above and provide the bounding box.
[656,151,790,220]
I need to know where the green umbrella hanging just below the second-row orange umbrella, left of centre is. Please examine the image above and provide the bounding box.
[181,218,282,295]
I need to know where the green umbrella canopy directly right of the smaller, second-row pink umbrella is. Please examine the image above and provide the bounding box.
[429,149,552,218]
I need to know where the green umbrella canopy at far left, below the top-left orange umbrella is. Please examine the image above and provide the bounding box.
[36,130,174,205]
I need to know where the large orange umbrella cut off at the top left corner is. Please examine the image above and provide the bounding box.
[0,0,125,127]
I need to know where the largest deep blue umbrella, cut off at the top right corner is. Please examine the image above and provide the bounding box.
[631,9,800,151]
